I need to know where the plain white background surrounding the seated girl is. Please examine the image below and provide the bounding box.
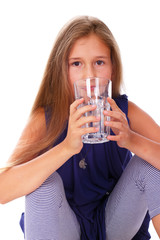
[0,0,160,240]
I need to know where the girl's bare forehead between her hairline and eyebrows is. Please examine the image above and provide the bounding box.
[69,34,110,56]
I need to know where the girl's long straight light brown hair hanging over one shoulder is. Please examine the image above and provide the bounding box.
[1,16,122,169]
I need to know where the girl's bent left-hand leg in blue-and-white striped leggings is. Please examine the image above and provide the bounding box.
[25,172,80,240]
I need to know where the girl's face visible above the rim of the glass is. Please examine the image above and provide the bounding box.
[68,34,112,86]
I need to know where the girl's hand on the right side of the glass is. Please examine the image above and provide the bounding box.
[104,98,132,148]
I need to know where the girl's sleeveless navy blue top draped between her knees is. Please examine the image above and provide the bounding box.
[21,95,150,240]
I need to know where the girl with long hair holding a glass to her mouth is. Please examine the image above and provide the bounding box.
[0,16,160,240]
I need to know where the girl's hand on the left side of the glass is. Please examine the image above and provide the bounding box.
[64,98,100,155]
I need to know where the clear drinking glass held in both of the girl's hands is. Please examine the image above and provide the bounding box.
[74,77,112,144]
